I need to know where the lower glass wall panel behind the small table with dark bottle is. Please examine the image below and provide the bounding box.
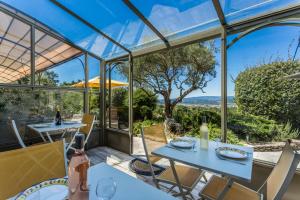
[0,88,83,150]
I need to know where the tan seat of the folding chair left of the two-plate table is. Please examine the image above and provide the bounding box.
[157,165,202,189]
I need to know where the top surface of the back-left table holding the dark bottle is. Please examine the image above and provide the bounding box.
[27,122,86,133]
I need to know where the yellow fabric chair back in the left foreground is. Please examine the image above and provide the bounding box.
[0,141,67,199]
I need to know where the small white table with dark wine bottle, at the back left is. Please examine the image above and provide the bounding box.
[27,122,86,142]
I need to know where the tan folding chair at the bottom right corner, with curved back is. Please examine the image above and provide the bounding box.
[201,141,300,200]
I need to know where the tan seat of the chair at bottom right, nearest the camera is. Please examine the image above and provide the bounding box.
[201,176,260,200]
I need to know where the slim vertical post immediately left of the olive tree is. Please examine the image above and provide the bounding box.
[128,54,133,154]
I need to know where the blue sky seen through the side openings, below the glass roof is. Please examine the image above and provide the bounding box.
[52,26,300,98]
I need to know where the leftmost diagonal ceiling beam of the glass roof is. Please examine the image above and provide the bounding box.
[50,0,131,53]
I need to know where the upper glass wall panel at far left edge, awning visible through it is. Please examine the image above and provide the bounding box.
[0,9,31,85]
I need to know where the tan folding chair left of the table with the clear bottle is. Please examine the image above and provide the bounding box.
[141,124,204,196]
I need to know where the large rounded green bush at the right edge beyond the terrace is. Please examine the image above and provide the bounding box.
[235,61,300,127]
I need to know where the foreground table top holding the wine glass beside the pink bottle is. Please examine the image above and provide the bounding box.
[88,163,176,200]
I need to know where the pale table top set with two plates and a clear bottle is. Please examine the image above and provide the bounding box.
[152,138,253,182]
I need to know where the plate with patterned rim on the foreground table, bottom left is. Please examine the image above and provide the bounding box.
[16,178,68,200]
